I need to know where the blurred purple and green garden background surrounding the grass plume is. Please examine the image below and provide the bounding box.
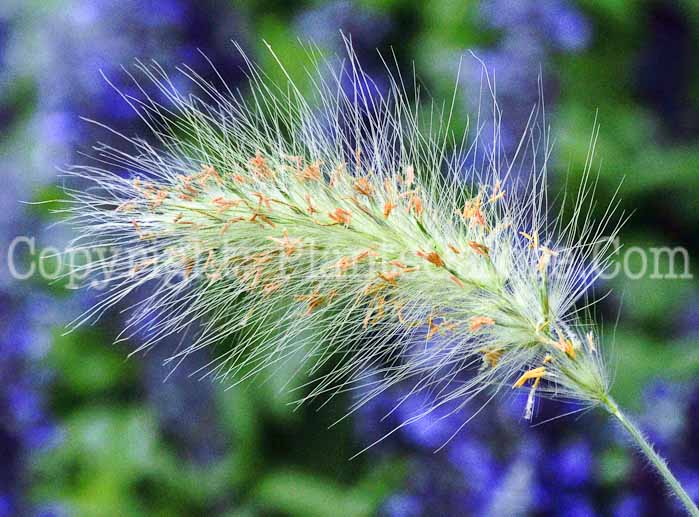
[0,0,699,517]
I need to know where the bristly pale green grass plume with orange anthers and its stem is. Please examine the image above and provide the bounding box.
[67,45,699,515]
